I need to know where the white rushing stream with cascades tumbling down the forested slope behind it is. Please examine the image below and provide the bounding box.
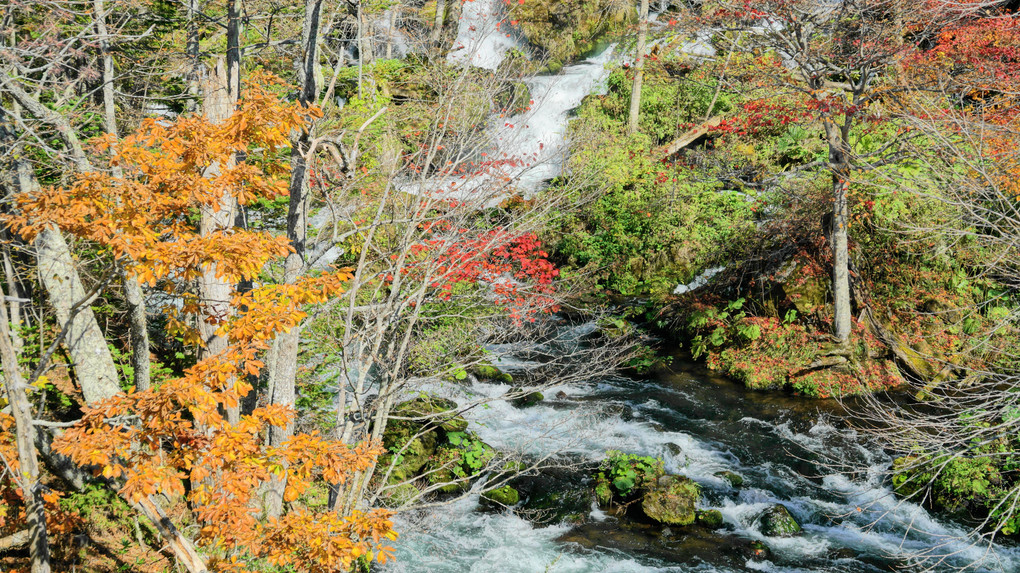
[383,5,1020,573]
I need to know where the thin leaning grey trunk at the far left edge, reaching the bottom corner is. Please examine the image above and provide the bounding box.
[0,283,50,573]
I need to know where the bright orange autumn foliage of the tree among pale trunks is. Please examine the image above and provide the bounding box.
[6,74,396,572]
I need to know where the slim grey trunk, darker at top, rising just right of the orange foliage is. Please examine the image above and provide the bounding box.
[265,0,322,517]
